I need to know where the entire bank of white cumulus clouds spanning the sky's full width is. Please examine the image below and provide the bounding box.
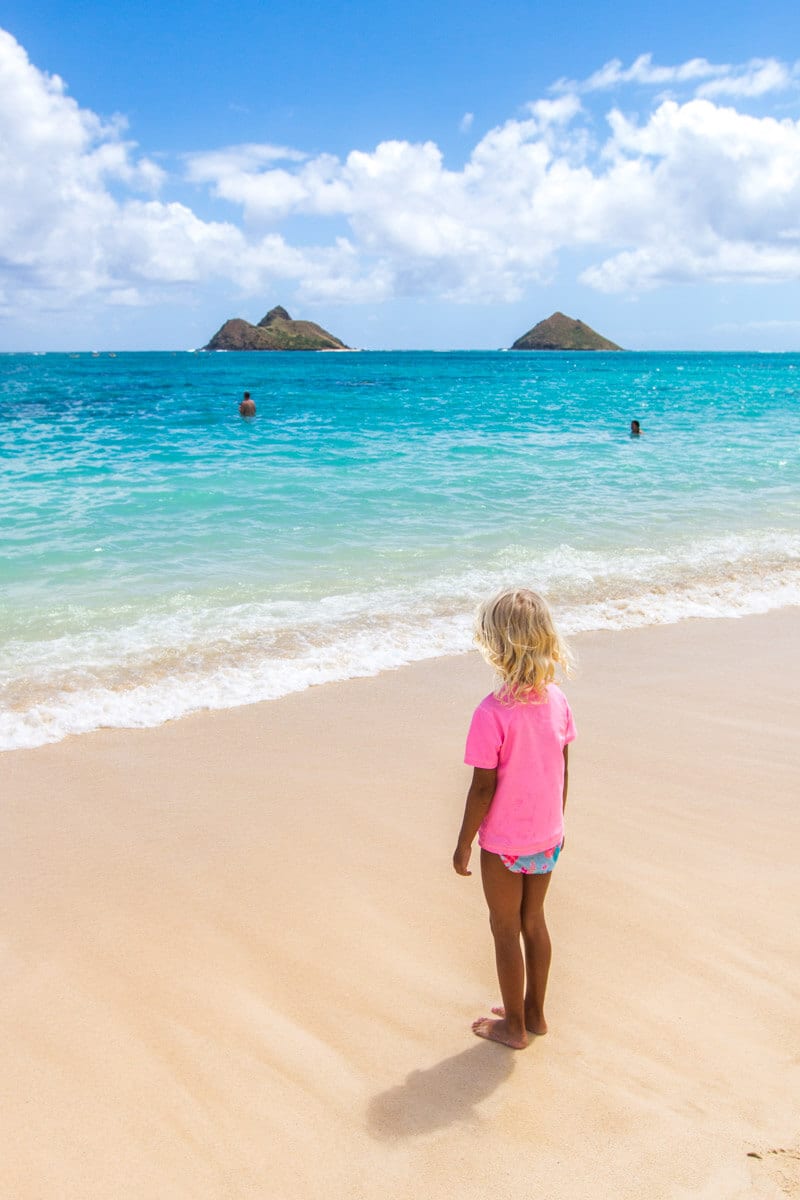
[0,32,800,314]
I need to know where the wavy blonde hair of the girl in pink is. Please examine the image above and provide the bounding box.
[475,588,570,703]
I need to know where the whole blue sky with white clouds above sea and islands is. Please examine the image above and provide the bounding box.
[0,0,800,352]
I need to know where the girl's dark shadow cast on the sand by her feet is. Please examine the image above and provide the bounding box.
[367,1042,515,1139]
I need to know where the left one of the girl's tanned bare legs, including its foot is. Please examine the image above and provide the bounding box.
[473,850,528,1050]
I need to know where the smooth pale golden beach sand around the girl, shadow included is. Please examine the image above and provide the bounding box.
[0,610,800,1200]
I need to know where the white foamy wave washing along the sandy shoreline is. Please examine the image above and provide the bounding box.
[0,535,800,750]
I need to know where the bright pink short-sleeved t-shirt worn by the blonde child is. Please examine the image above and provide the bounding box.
[464,683,576,854]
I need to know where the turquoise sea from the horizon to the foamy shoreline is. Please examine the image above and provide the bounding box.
[0,352,800,748]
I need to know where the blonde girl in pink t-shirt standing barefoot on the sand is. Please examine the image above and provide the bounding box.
[453,588,576,1050]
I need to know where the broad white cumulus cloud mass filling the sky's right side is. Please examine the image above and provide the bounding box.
[179,95,800,300]
